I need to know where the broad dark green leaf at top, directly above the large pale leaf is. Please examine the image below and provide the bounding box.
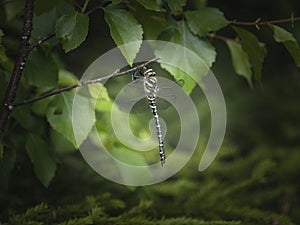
[184,8,229,37]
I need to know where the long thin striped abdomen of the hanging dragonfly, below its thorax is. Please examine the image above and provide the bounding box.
[147,96,166,166]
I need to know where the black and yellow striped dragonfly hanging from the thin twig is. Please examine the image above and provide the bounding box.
[133,67,166,166]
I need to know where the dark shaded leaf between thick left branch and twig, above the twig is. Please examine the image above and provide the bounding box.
[24,51,58,92]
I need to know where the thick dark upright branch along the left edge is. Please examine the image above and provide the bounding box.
[0,0,34,130]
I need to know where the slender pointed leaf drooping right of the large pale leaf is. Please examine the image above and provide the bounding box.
[226,40,252,87]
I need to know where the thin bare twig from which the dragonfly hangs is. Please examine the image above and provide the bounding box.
[10,57,160,108]
